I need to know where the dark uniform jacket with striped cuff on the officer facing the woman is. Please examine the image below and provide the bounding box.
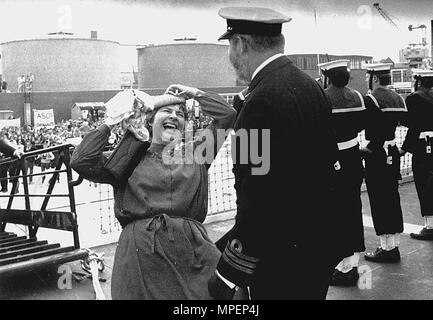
[217,56,344,285]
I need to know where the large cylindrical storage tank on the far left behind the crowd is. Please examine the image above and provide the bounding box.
[1,38,121,92]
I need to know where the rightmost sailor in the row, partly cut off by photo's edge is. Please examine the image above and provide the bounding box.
[401,70,433,240]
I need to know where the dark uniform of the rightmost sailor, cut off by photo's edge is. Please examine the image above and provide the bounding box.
[402,90,433,216]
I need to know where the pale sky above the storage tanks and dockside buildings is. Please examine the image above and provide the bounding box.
[0,0,433,70]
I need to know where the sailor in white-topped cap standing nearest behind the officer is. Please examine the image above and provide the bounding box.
[318,60,375,286]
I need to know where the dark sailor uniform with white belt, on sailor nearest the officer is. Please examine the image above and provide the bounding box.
[325,86,371,253]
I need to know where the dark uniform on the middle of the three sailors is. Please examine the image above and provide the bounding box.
[365,88,407,235]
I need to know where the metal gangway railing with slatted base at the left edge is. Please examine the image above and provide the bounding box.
[0,145,88,276]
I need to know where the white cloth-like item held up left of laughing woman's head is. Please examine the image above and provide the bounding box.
[105,90,135,126]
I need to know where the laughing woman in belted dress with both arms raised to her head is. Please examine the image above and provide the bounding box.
[71,85,236,299]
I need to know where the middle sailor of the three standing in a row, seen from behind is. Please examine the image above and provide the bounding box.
[363,63,407,263]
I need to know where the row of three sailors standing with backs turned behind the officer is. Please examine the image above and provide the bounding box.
[319,60,433,286]
